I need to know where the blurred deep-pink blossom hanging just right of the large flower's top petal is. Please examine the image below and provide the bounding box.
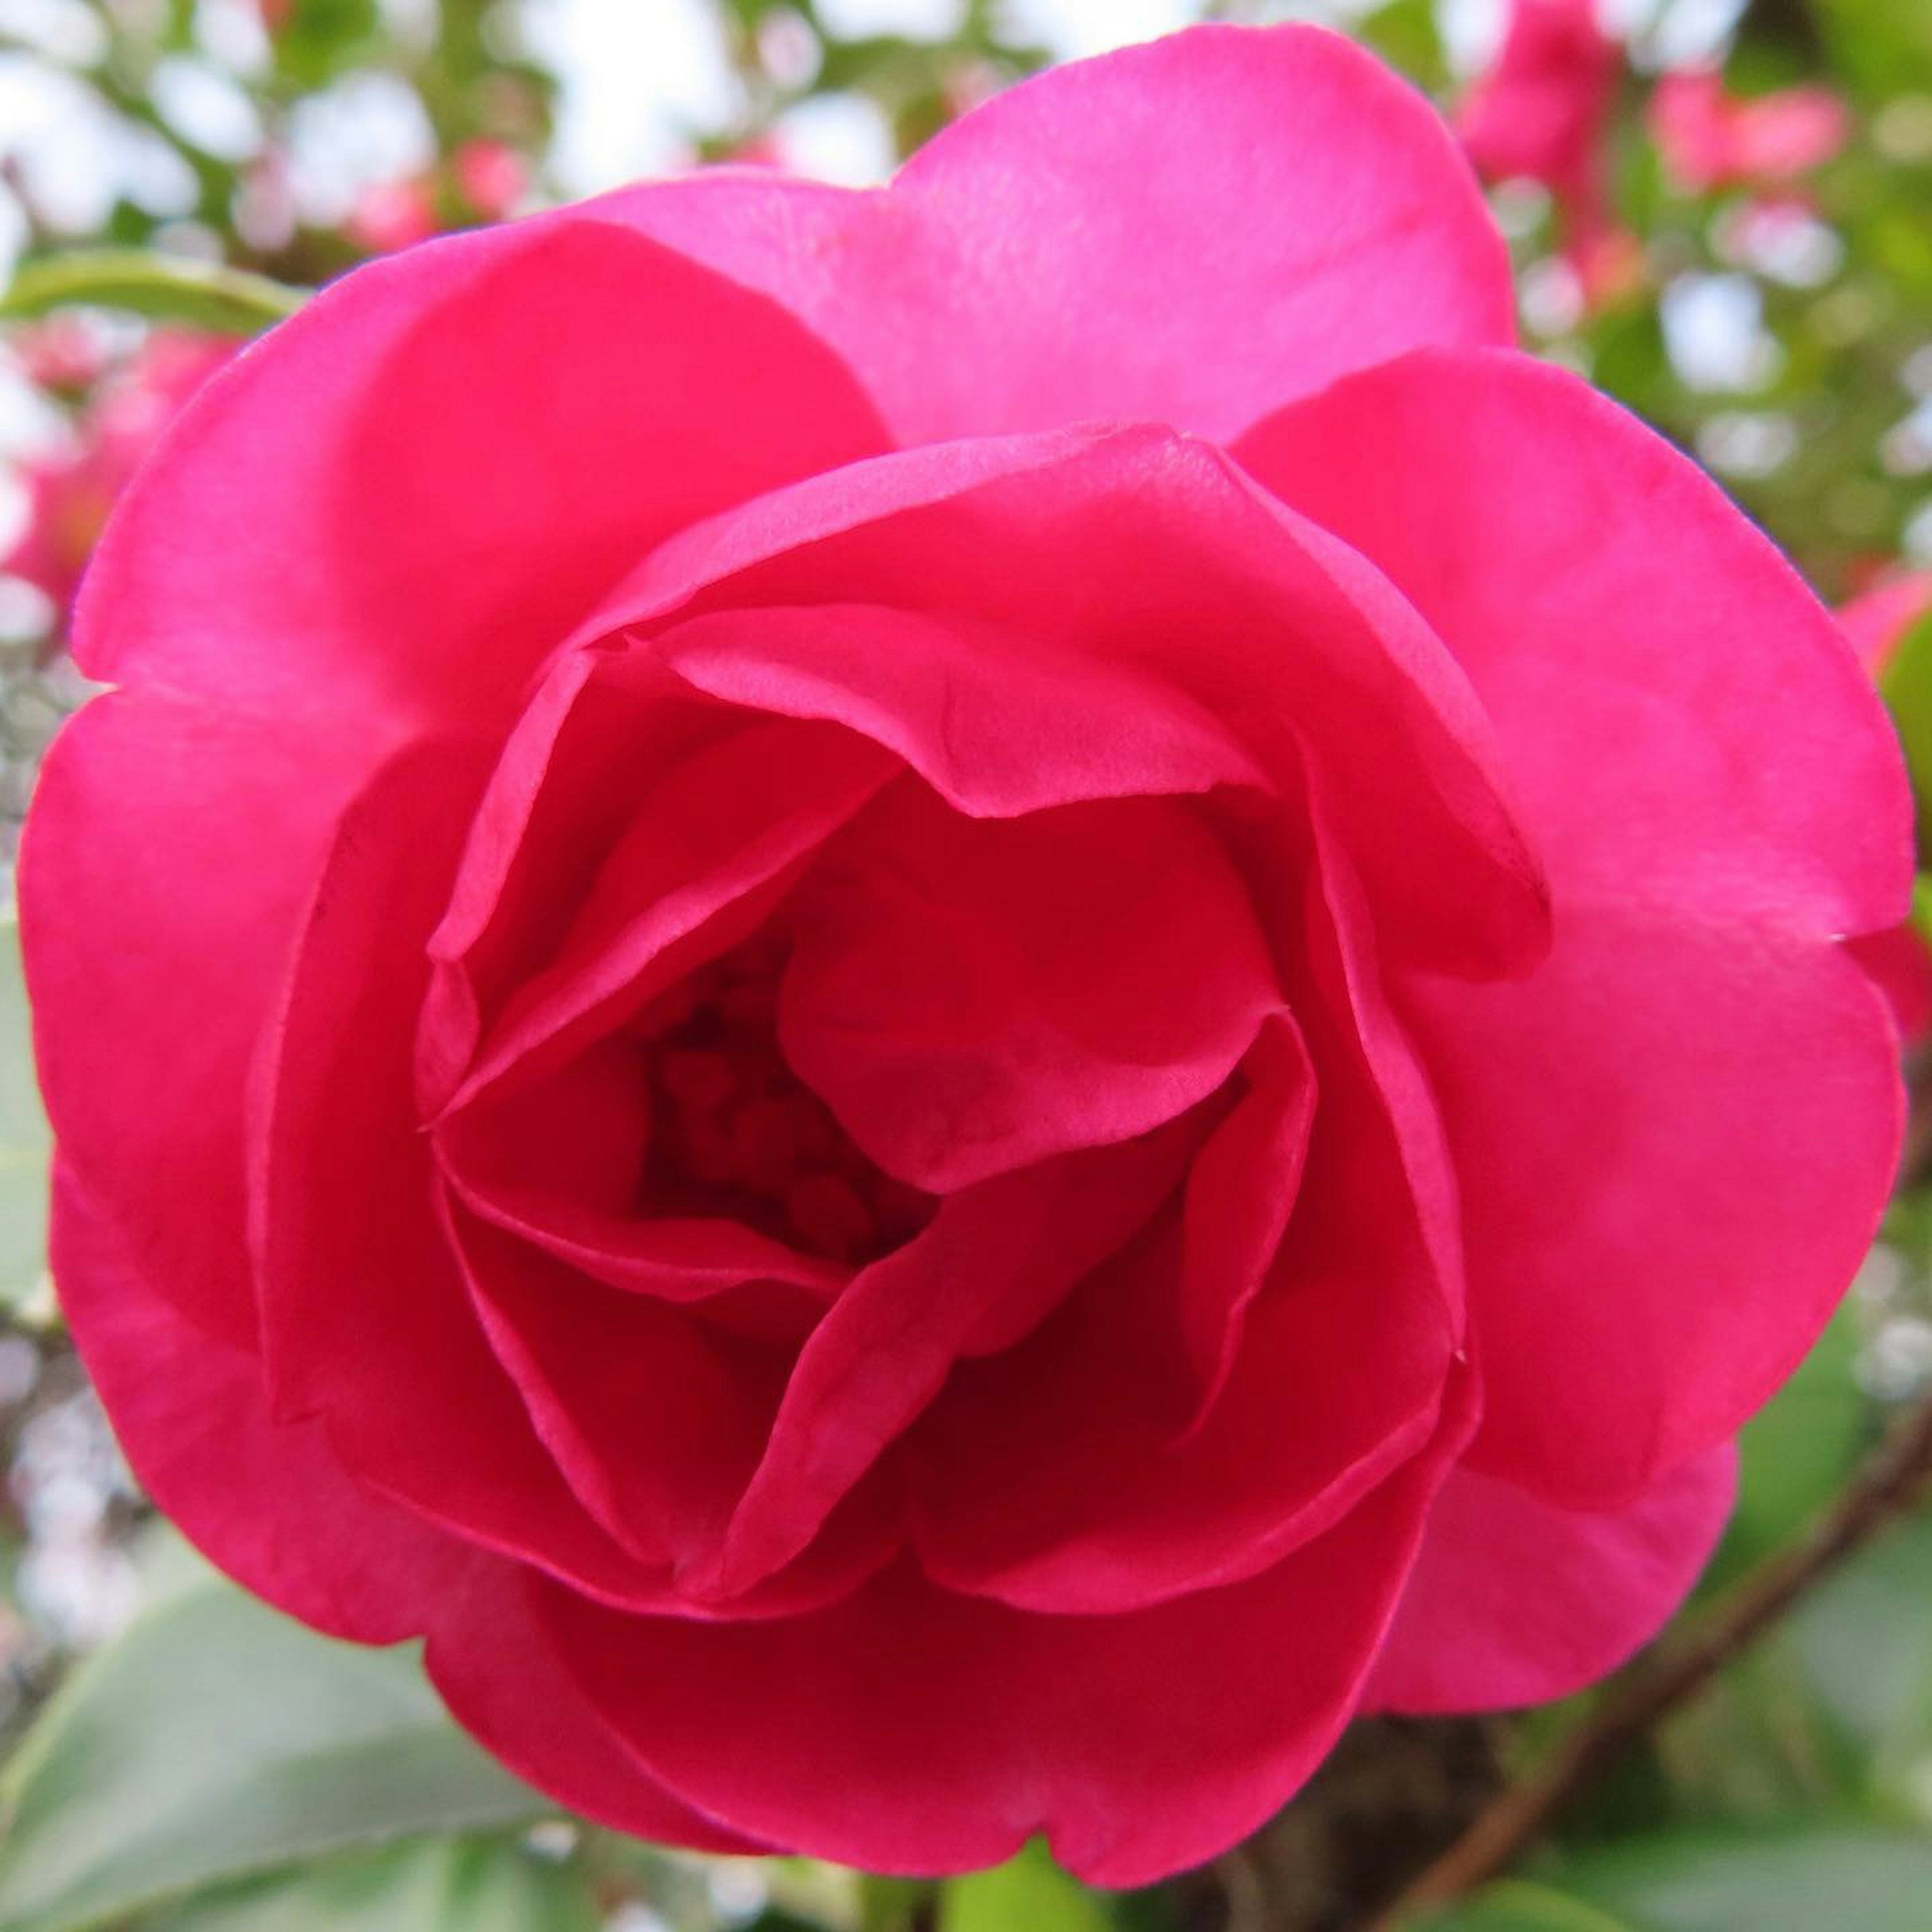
[1457,0,1627,286]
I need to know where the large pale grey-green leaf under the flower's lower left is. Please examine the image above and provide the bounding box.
[0,1526,554,1932]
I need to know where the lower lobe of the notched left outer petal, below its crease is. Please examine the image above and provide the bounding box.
[21,692,382,1350]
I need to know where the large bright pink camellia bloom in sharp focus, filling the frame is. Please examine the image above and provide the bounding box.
[23,27,1911,1884]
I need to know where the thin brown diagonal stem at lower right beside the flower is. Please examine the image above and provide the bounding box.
[1372,1395,1932,1932]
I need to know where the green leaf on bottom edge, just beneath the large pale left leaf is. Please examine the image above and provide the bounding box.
[145,1839,599,1932]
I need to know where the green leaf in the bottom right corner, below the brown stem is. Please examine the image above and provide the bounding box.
[1561,1826,1932,1932]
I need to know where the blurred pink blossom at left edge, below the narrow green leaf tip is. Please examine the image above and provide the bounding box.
[0,329,234,610]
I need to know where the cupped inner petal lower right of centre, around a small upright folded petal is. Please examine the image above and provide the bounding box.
[912,865,1463,1613]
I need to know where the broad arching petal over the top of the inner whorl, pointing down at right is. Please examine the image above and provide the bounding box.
[595,427,1550,976]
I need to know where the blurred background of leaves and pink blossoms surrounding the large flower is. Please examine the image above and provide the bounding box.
[0,0,1932,1932]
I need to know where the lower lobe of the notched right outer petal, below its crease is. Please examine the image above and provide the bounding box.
[1410,906,1903,1509]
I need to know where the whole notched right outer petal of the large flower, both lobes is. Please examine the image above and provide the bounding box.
[1238,354,1909,1507]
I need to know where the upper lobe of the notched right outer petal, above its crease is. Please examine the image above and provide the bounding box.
[1237,352,1911,937]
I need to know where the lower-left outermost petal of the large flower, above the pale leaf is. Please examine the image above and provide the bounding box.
[52,1167,475,1644]
